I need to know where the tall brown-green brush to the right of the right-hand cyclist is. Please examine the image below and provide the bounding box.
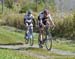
[52,14,75,40]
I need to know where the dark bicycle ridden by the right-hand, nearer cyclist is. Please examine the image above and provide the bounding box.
[38,24,52,51]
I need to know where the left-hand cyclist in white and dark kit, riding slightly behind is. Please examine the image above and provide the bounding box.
[24,10,35,43]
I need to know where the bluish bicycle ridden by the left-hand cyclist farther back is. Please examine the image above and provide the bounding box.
[25,25,34,46]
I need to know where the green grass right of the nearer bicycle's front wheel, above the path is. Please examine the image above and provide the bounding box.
[53,40,75,52]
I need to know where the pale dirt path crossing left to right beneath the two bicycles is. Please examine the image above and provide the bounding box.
[0,44,75,58]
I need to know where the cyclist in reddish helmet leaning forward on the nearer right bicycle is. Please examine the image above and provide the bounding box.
[38,9,55,48]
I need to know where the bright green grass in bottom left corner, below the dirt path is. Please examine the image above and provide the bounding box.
[0,49,38,59]
